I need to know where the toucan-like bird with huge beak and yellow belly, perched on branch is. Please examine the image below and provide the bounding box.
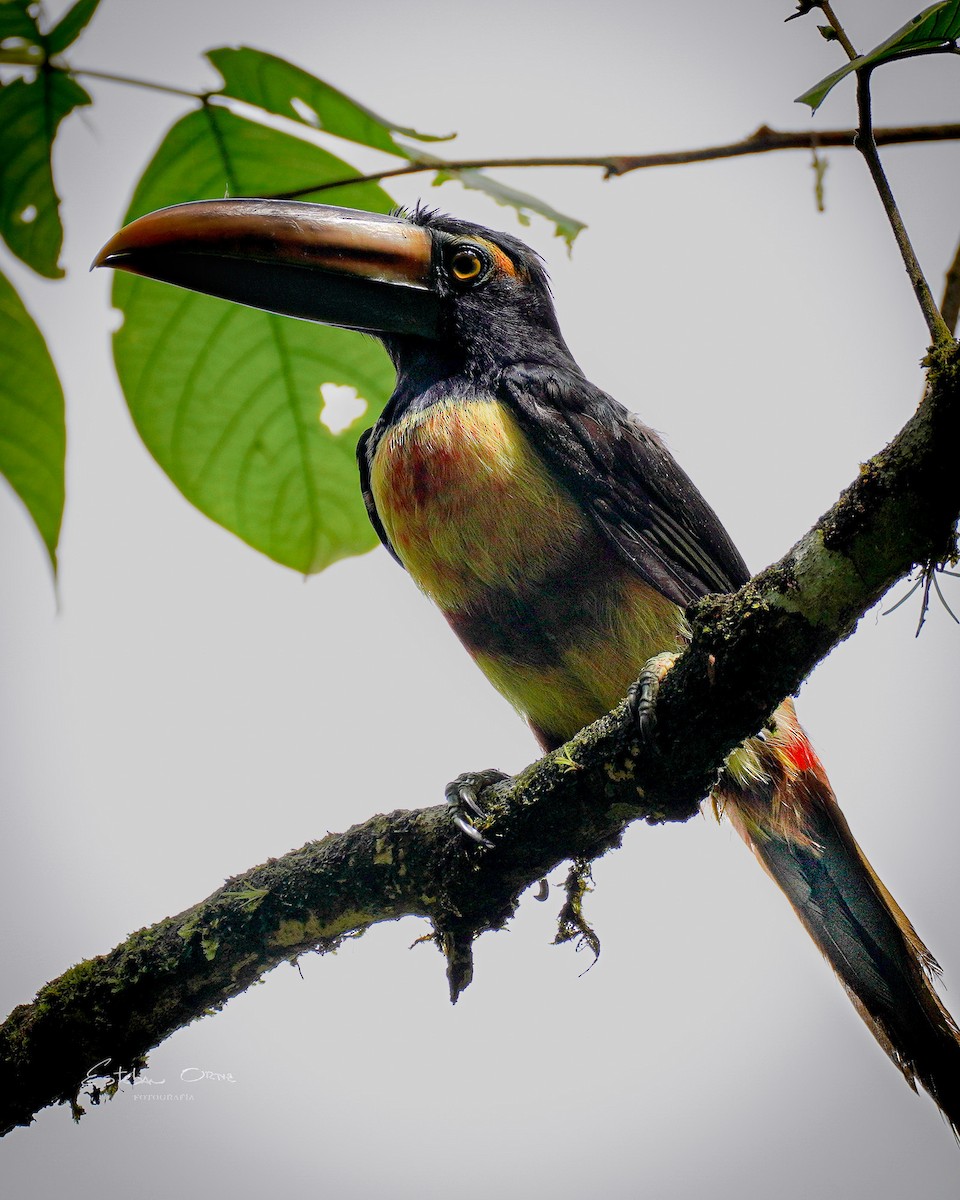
[97,199,960,1134]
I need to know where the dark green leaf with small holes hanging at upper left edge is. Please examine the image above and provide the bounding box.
[0,68,90,280]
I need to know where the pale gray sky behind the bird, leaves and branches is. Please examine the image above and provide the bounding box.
[0,0,960,1200]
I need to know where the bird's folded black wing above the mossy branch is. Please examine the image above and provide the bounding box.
[500,364,750,606]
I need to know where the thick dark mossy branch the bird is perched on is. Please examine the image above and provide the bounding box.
[0,343,960,1132]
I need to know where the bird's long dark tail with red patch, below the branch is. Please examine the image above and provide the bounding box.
[714,701,960,1138]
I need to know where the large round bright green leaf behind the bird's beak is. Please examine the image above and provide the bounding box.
[114,107,394,574]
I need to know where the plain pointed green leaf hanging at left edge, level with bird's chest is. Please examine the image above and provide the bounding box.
[0,264,66,571]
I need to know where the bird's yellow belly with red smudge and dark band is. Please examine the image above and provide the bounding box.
[371,401,684,738]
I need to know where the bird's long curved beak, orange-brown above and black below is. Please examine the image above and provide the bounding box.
[94,199,440,337]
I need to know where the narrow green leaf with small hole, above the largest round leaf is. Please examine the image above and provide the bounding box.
[206,46,452,157]
